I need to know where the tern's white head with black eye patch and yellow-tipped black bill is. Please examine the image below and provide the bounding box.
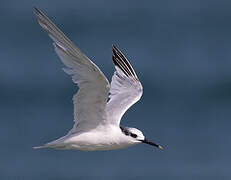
[120,127,163,149]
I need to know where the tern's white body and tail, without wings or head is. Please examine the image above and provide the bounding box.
[44,125,140,151]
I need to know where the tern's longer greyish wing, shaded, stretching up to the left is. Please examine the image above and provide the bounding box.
[35,8,110,133]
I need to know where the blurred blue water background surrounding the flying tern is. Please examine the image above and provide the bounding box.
[0,0,231,180]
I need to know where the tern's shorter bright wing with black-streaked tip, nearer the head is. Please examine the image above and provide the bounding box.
[107,45,143,125]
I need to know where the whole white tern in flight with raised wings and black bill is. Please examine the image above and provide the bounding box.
[34,8,162,151]
